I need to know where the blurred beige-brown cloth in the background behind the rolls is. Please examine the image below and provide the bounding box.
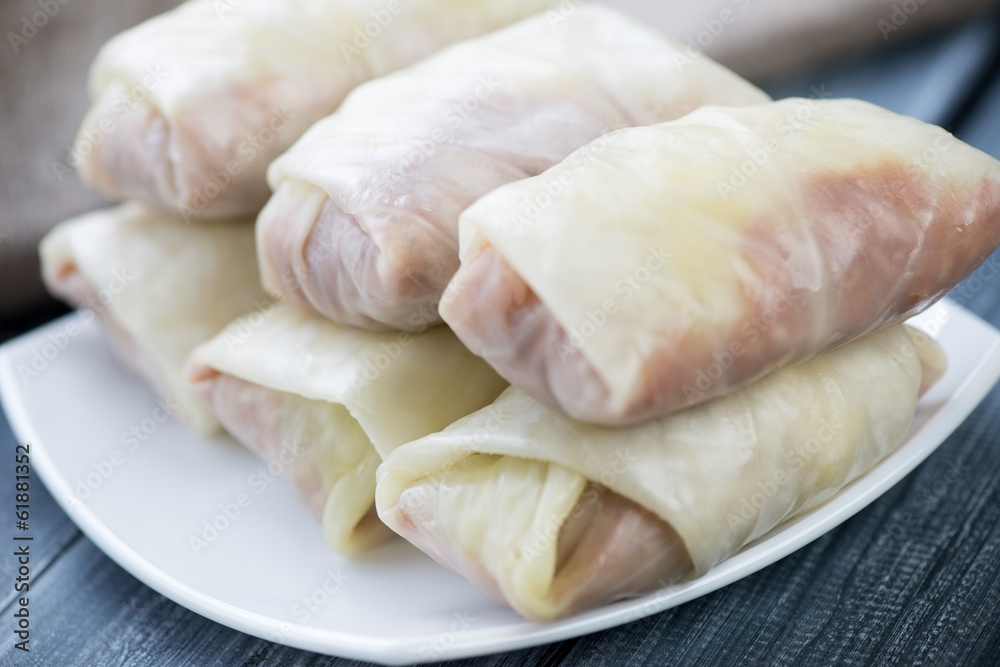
[0,0,1000,320]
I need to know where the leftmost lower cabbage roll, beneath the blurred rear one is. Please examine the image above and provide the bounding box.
[40,202,271,433]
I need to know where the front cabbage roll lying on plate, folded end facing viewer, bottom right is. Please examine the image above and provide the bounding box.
[376,326,945,620]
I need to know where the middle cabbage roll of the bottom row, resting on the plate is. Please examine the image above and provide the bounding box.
[186,304,506,554]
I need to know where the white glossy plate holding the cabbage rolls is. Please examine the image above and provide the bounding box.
[0,303,1000,664]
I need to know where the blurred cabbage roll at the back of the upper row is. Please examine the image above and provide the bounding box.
[73,0,554,217]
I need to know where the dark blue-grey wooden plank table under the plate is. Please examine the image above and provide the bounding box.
[0,5,1000,667]
